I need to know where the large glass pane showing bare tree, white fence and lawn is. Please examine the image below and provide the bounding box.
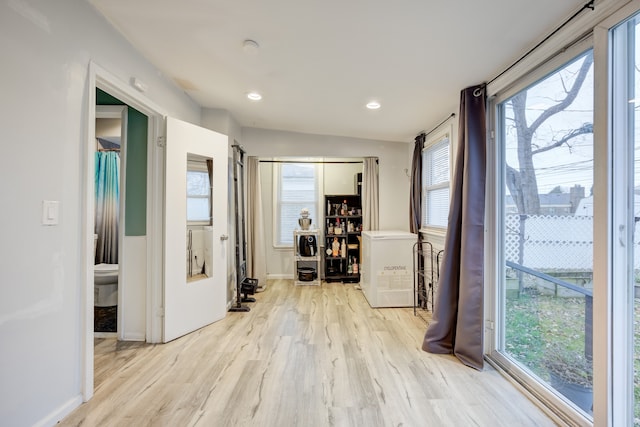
[496,50,594,418]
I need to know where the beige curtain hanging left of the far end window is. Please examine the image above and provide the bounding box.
[247,157,267,292]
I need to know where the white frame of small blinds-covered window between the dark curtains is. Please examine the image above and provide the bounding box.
[420,123,454,237]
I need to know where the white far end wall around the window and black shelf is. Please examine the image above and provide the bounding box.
[242,128,411,277]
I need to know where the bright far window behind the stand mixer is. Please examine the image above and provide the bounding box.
[273,163,322,247]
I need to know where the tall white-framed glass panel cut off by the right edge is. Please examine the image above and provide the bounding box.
[611,15,640,426]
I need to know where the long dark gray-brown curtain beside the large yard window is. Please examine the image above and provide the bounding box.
[422,85,486,369]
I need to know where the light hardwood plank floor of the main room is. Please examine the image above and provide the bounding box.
[60,280,554,427]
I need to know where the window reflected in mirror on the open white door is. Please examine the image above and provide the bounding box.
[187,161,211,224]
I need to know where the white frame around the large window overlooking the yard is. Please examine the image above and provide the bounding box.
[484,0,640,426]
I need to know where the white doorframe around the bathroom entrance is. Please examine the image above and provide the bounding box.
[80,61,166,402]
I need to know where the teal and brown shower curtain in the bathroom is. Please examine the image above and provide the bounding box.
[95,151,120,264]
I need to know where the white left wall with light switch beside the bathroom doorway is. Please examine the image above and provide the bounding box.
[0,0,200,426]
